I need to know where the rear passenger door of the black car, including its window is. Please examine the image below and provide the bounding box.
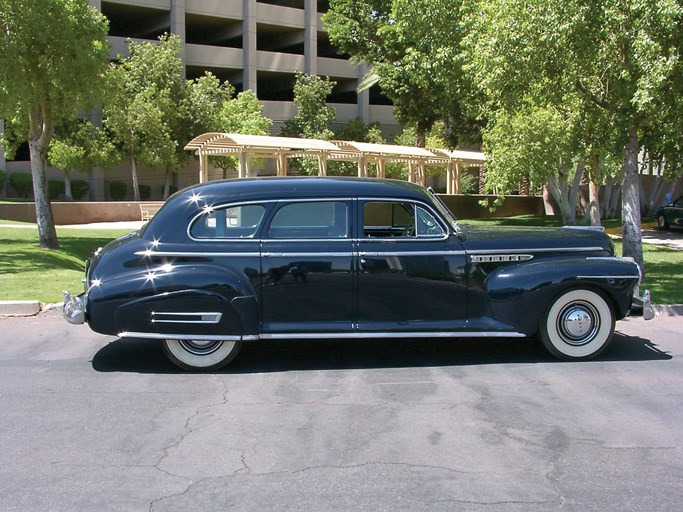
[260,199,355,338]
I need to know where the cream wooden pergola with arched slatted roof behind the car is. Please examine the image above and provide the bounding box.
[185,132,486,194]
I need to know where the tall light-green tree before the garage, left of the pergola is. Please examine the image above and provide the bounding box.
[104,35,185,201]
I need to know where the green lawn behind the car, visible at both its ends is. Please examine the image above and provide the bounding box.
[0,216,683,304]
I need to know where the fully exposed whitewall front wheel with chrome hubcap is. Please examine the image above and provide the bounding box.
[539,289,615,361]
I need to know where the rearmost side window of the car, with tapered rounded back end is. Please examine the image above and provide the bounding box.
[190,204,265,238]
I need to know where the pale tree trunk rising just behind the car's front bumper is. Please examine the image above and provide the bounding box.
[621,128,645,277]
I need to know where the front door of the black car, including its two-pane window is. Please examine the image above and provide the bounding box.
[357,199,467,335]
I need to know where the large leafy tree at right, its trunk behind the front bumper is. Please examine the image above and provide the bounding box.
[467,0,683,278]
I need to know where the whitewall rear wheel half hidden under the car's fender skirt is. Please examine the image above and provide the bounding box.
[164,340,242,371]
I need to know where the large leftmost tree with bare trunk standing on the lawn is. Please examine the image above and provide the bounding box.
[0,0,109,249]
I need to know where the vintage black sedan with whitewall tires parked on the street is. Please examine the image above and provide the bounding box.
[64,178,653,370]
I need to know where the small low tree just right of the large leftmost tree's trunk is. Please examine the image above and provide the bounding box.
[48,117,119,201]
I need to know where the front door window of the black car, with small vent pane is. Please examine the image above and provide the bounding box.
[363,201,444,238]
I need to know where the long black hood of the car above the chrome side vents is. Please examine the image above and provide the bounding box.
[461,224,614,255]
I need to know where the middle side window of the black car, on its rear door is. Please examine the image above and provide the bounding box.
[268,201,348,238]
